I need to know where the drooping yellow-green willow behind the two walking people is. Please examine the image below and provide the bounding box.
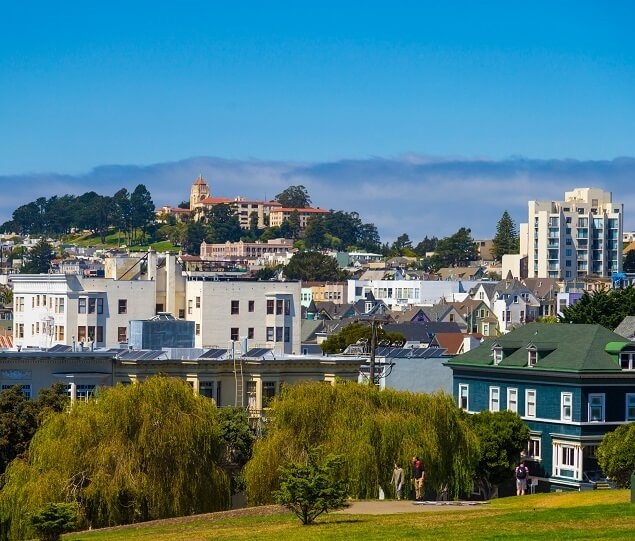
[245,383,478,504]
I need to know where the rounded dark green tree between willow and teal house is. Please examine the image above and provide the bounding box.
[466,411,529,500]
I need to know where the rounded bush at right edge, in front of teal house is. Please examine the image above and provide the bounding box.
[597,423,635,488]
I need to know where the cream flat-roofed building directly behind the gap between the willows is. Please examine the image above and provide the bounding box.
[185,280,301,353]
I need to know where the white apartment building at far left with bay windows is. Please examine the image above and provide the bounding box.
[9,274,156,348]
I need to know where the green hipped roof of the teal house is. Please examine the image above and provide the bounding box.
[447,323,635,372]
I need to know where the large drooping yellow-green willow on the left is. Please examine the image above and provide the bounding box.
[0,377,230,539]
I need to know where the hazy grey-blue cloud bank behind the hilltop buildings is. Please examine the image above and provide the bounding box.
[0,155,635,243]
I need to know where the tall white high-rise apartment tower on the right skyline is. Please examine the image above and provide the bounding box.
[520,188,624,280]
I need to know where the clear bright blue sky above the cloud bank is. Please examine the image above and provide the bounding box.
[0,0,635,238]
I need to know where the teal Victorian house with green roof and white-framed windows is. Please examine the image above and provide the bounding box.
[446,323,635,491]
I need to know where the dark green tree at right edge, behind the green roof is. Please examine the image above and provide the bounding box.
[560,286,635,330]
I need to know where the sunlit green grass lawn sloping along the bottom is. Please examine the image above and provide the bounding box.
[64,490,635,541]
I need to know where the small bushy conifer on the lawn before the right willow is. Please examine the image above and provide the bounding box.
[274,449,346,525]
